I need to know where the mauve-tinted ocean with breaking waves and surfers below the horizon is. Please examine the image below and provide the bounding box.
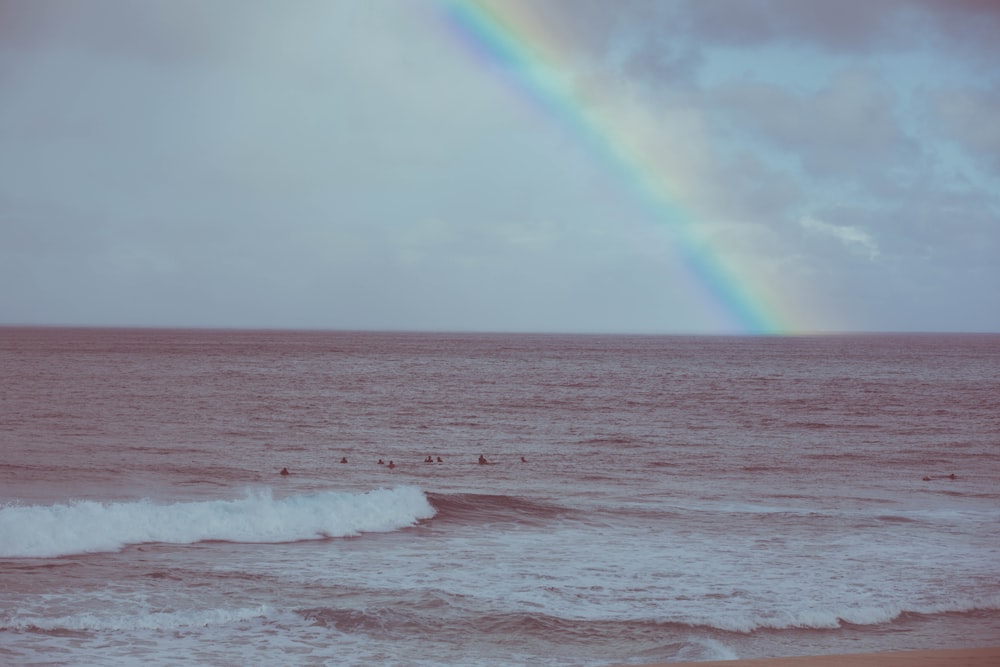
[0,327,1000,667]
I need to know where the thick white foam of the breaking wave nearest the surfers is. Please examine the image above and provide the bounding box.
[0,486,435,558]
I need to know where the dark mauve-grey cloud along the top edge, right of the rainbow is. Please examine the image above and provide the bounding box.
[531,0,1000,82]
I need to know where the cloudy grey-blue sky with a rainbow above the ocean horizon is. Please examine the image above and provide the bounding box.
[0,0,1000,334]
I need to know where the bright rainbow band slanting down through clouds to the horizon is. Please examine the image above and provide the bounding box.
[438,0,798,334]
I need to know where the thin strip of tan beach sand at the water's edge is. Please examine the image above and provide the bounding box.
[608,646,1000,667]
